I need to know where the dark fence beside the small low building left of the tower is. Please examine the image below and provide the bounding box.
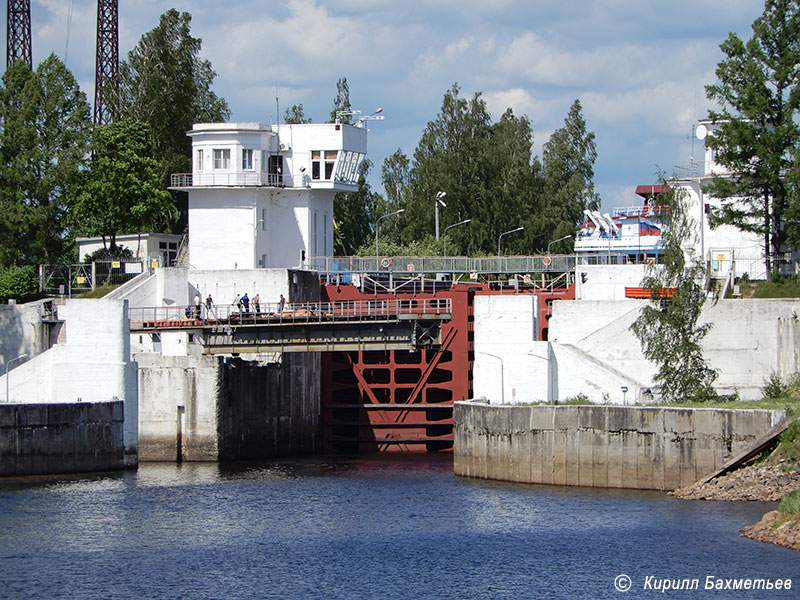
[39,260,146,297]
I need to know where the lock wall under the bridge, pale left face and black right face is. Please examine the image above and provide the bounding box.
[136,353,321,461]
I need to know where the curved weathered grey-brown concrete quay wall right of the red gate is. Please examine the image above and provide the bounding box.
[453,402,785,490]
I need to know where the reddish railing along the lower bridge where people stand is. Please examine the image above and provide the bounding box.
[128,298,453,329]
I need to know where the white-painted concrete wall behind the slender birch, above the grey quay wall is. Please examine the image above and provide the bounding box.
[536,299,800,404]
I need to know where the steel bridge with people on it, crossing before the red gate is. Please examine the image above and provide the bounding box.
[128,298,452,355]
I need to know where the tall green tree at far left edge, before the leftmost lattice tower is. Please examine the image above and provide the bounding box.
[0,54,91,265]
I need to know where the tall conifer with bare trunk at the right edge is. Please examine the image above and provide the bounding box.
[706,0,800,274]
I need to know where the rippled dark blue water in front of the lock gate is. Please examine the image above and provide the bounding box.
[0,455,800,600]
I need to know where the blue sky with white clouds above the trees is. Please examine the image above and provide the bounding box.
[0,0,763,210]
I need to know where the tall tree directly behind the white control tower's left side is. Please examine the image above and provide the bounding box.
[117,9,230,184]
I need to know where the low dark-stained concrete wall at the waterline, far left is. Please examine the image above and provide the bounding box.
[0,401,126,476]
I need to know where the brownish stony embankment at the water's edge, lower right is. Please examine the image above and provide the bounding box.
[671,460,800,551]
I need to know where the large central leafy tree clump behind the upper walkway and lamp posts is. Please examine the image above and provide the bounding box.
[394,84,533,254]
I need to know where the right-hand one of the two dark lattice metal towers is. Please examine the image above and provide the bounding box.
[94,0,119,127]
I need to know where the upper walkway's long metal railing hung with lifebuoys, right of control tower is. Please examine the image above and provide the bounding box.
[307,254,577,275]
